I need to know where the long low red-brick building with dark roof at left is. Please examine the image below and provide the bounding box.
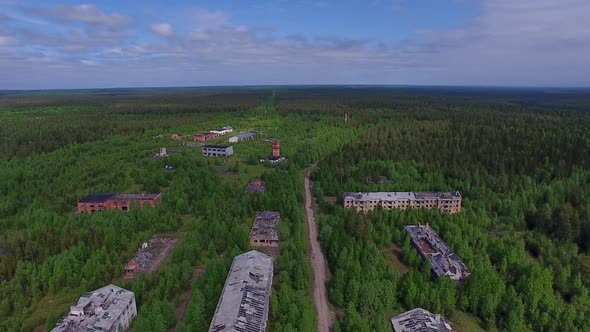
[77,193,162,213]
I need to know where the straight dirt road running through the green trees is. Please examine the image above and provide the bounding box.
[305,171,334,332]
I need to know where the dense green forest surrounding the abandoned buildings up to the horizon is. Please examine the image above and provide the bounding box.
[0,87,590,332]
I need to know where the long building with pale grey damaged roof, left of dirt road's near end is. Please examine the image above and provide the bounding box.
[209,250,273,332]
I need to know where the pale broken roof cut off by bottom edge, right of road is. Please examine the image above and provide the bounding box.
[391,308,453,332]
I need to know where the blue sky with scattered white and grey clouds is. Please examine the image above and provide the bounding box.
[0,0,590,89]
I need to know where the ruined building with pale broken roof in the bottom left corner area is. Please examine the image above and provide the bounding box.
[51,285,137,332]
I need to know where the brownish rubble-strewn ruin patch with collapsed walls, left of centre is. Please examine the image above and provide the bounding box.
[124,235,178,279]
